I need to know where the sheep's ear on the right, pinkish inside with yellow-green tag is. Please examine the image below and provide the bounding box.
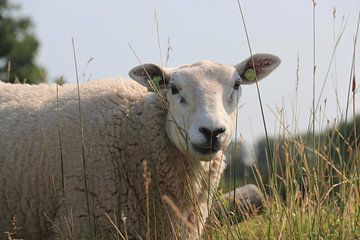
[234,54,281,84]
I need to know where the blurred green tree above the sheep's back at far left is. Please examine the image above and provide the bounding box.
[0,0,46,84]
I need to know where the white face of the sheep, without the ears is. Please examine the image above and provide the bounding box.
[166,62,241,159]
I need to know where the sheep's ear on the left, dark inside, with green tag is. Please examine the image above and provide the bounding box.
[129,63,170,92]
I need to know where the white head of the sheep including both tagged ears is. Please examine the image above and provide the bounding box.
[129,54,280,161]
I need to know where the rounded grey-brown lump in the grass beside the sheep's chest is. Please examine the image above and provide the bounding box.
[212,184,264,224]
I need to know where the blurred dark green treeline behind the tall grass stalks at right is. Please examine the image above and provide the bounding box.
[223,115,360,197]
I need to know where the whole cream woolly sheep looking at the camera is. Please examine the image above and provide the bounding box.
[0,54,280,239]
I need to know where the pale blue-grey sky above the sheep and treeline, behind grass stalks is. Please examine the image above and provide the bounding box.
[16,0,360,143]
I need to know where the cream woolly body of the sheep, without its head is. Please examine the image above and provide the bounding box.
[0,80,223,239]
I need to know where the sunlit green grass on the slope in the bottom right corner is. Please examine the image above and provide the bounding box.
[204,199,360,239]
